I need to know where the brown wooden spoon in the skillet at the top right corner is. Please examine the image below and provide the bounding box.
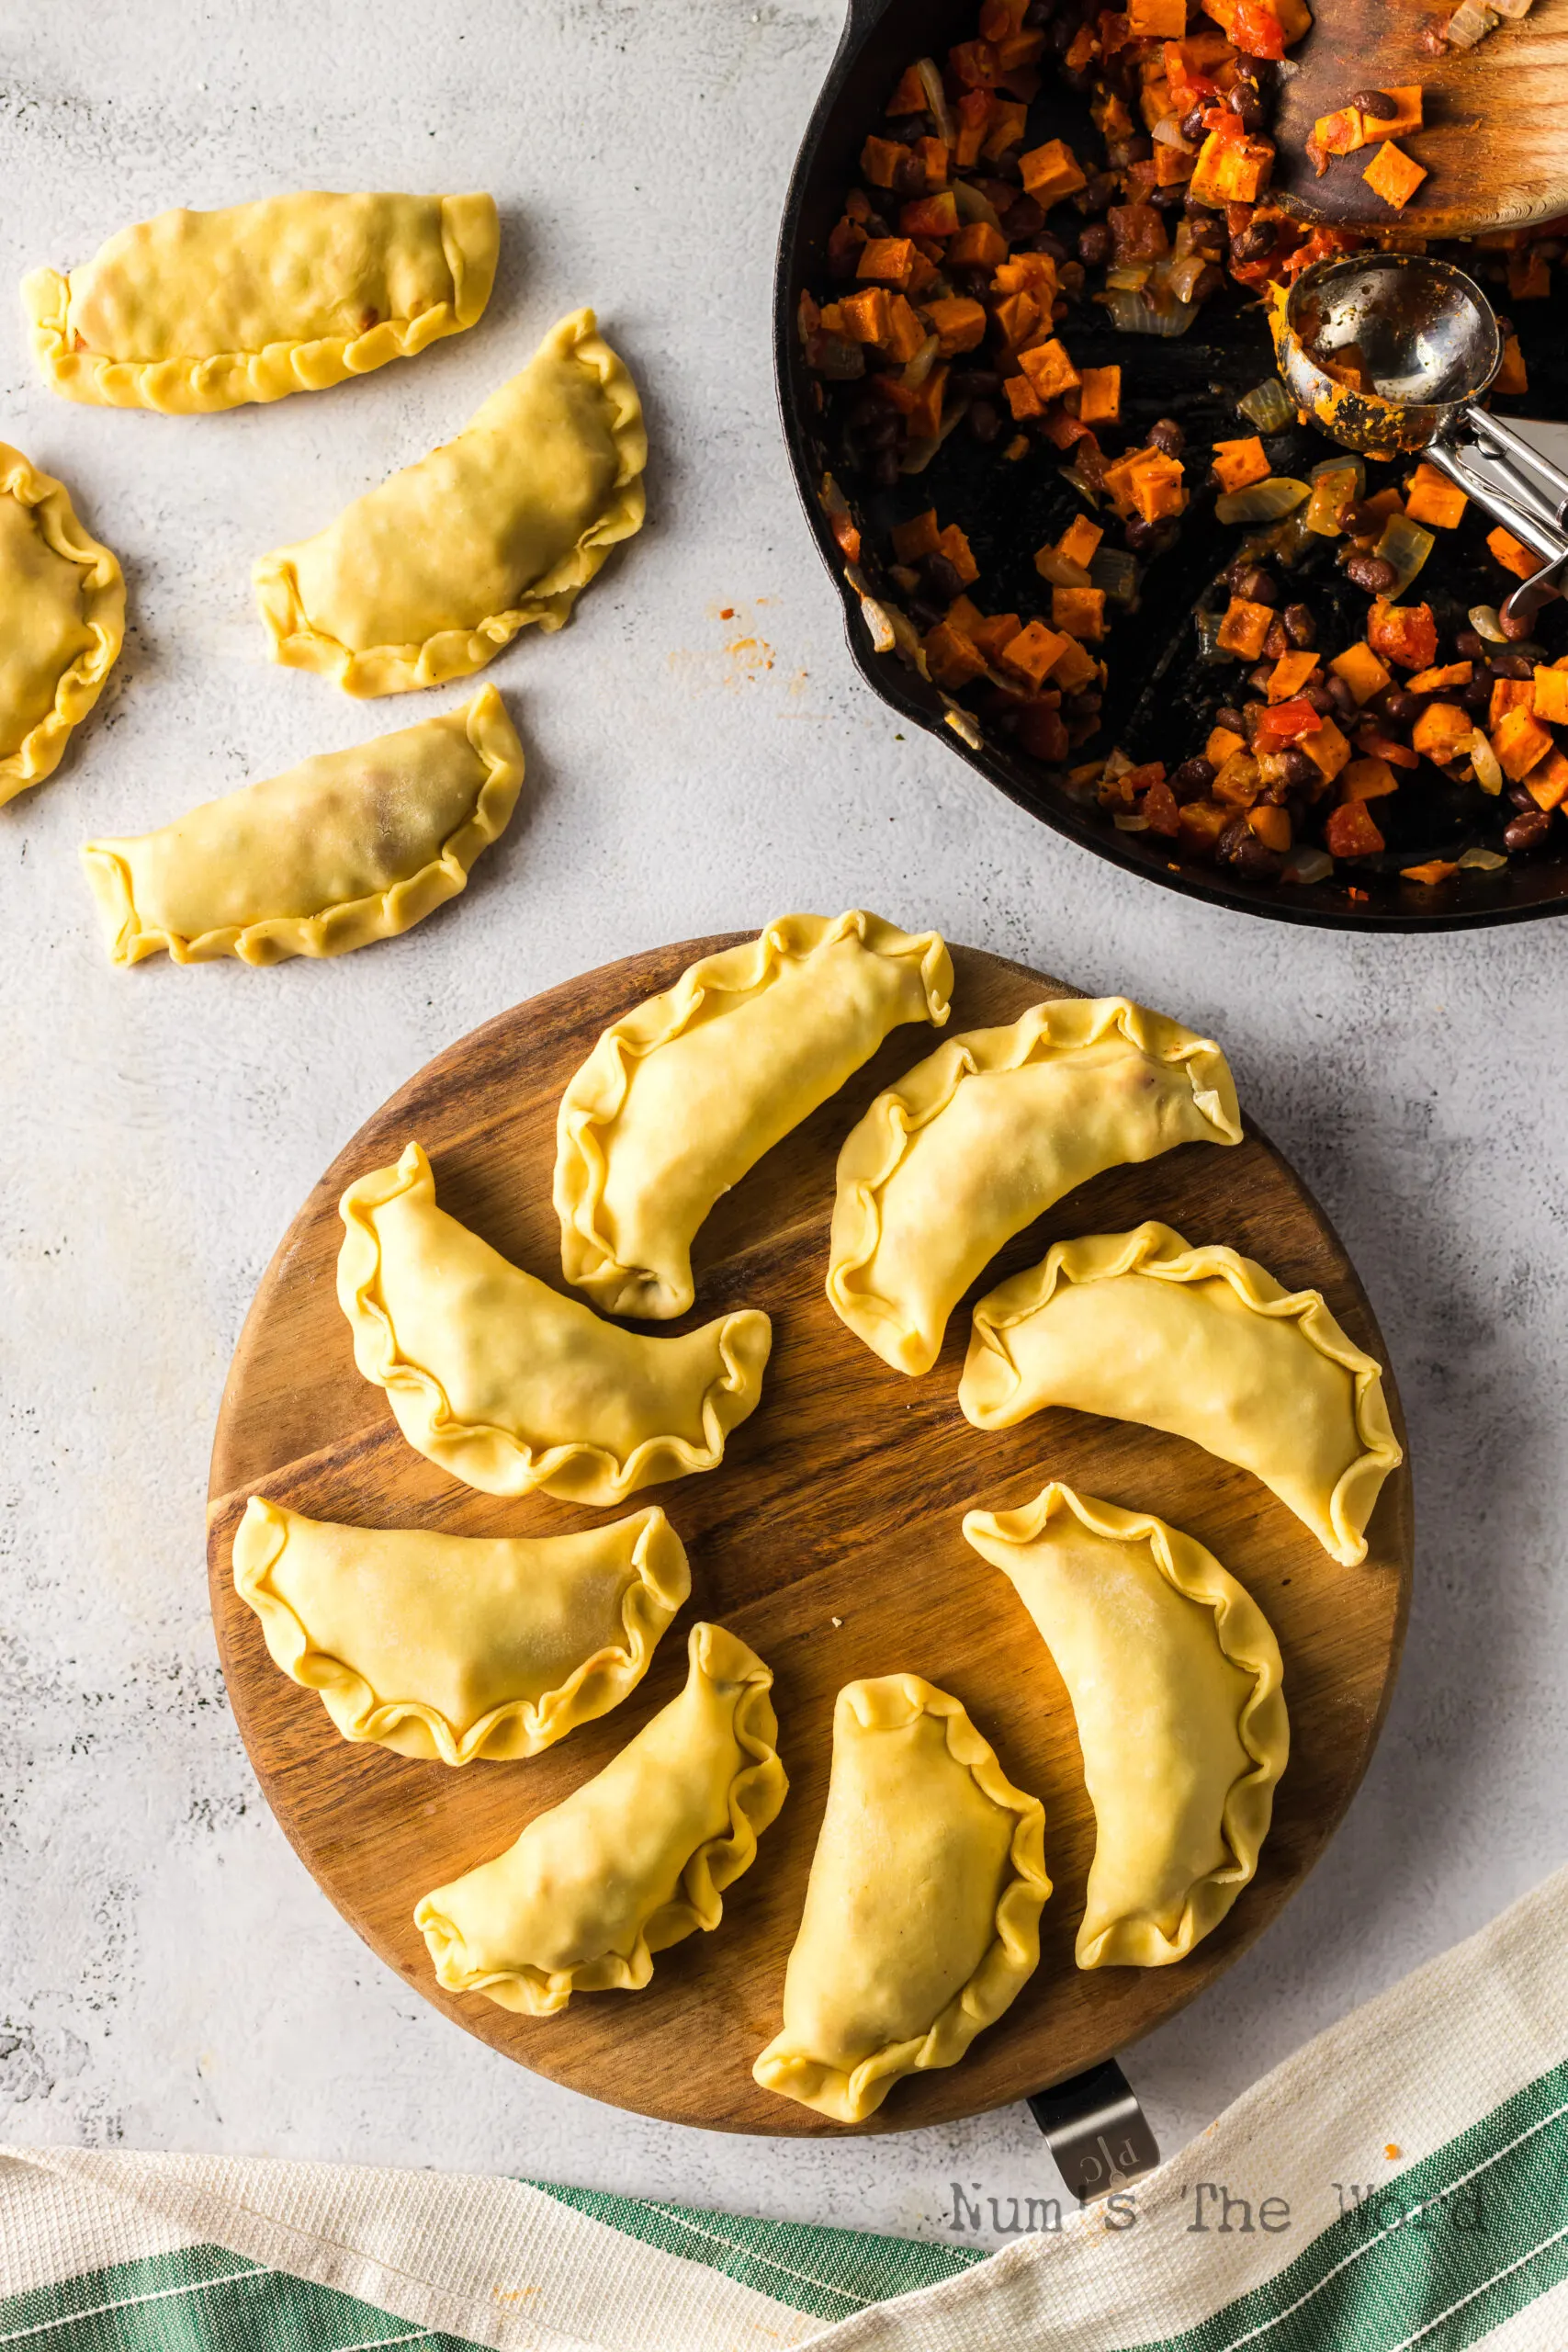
[1272,0,1568,238]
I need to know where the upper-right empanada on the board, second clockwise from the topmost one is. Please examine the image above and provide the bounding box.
[828,997,1241,1374]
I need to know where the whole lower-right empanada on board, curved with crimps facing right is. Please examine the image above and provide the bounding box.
[964,1482,1291,1969]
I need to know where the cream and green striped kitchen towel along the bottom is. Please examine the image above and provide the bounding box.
[0,1872,1568,2352]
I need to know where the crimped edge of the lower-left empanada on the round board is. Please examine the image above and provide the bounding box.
[413,1621,790,2018]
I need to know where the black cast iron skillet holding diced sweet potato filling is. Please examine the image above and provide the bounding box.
[773,0,1568,932]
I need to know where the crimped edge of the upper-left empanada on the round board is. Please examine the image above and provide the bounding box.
[339,1143,773,1508]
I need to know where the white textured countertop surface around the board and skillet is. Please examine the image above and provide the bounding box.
[0,0,1568,2234]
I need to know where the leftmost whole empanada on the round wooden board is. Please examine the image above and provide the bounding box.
[232,1494,691,1764]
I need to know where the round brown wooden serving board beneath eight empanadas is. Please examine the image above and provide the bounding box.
[207,938,1411,2133]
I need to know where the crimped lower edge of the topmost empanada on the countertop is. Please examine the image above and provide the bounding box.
[21,195,501,416]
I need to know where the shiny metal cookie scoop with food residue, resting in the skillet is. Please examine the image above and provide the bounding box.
[1269,254,1568,618]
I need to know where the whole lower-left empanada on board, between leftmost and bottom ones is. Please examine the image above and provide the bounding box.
[413,1625,790,2018]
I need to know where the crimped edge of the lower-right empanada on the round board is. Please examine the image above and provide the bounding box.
[964,1479,1291,1969]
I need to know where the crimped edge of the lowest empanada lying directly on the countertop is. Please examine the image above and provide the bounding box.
[80,684,525,969]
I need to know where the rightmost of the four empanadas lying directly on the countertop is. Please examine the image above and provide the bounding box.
[254,311,649,694]
